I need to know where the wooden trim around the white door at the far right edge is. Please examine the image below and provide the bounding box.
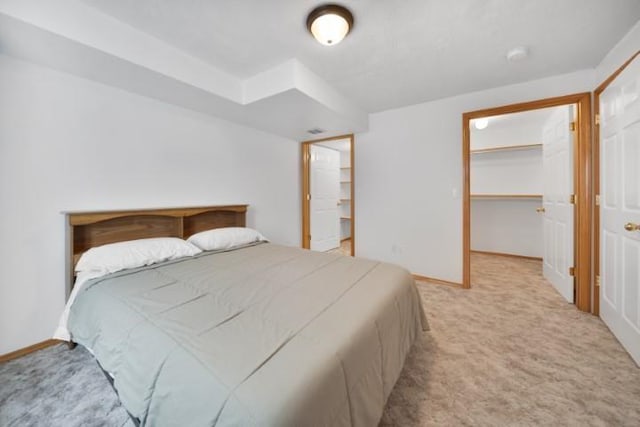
[592,50,640,316]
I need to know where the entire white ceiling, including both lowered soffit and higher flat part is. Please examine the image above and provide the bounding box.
[0,0,640,141]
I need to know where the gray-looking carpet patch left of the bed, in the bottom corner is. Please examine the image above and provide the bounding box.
[0,344,133,427]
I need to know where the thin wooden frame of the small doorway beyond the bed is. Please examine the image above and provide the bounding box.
[301,133,356,256]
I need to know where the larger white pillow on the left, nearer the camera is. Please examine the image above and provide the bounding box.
[76,237,202,274]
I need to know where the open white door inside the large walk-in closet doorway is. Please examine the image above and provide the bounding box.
[542,106,575,303]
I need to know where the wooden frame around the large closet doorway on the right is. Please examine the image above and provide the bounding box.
[462,92,593,312]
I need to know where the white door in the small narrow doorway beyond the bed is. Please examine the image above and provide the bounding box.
[309,145,340,252]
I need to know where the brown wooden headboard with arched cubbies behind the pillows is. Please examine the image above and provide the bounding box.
[64,205,248,298]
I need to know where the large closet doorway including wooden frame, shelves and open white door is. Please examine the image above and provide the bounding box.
[463,94,591,311]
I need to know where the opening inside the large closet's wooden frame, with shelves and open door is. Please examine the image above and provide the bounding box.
[470,104,577,303]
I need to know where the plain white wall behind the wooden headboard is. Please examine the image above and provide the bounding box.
[0,55,300,354]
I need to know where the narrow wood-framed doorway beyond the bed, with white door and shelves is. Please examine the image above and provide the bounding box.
[302,135,355,256]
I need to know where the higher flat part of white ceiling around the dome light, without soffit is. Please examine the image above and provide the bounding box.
[83,0,640,112]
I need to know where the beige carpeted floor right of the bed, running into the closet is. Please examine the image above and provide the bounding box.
[381,254,640,426]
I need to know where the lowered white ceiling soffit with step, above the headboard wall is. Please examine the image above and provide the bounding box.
[0,0,369,140]
